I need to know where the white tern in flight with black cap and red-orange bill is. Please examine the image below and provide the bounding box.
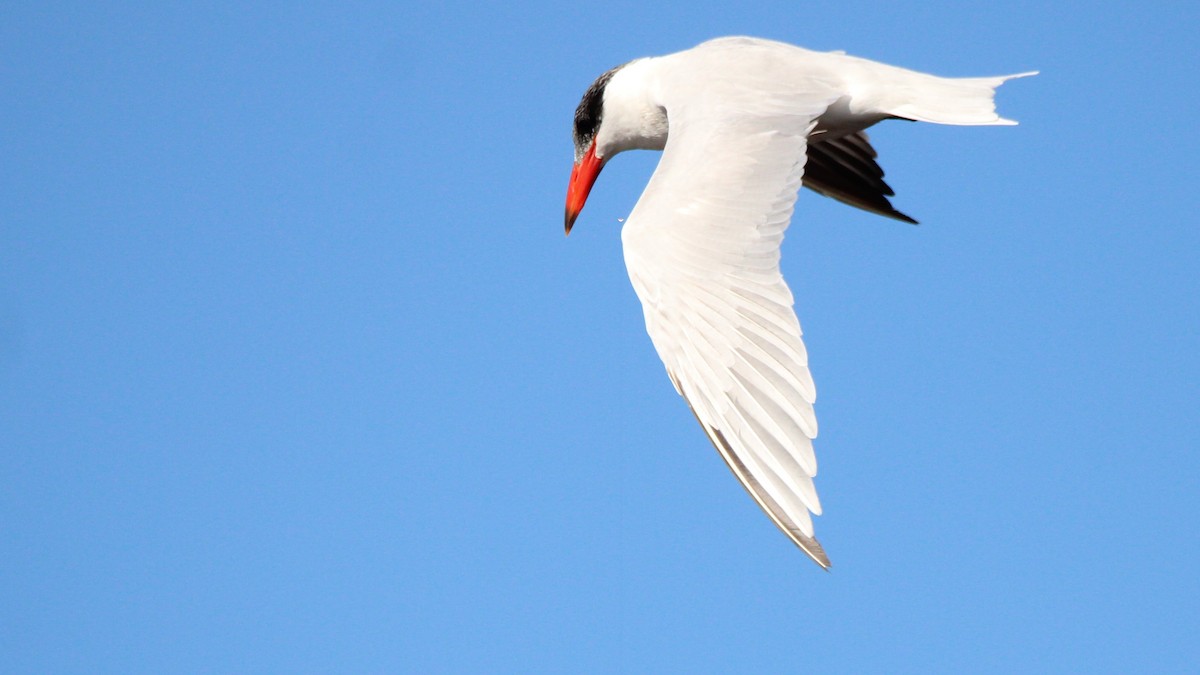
[566,37,1036,568]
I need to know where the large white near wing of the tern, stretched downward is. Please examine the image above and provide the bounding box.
[622,66,836,568]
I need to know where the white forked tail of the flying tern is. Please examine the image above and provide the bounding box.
[878,68,1038,125]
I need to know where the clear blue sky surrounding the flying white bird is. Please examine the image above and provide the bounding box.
[0,1,1200,673]
